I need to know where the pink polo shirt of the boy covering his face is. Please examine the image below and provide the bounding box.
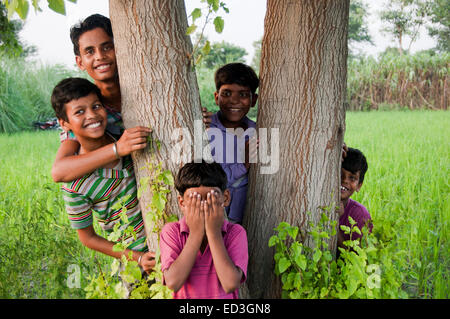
[159,217,248,299]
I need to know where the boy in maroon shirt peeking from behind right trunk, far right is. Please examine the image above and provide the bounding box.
[338,147,372,248]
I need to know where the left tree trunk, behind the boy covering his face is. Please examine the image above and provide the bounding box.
[110,0,207,254]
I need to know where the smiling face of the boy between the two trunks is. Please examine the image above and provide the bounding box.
[214,84,258,129]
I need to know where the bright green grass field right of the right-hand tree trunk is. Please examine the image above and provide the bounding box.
[345,111,450,298]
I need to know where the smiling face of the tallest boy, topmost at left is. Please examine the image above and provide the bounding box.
[75,28,117,82]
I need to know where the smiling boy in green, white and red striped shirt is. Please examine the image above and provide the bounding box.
[51,78,155,273]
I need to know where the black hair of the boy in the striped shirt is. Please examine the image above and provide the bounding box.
[51,78,102,122]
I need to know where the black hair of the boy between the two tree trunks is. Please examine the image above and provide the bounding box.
[214,62,259,94]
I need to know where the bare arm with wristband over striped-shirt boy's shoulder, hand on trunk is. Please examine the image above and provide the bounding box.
[52,126,151,183]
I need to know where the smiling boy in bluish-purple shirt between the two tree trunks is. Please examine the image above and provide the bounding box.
[207,63,259,223]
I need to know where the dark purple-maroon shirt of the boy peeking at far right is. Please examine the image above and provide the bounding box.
[339,198,373,240]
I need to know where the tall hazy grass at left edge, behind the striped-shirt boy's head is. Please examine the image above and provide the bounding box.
[0,56,83,133]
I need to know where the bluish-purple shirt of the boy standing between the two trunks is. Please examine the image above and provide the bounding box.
[207,111,256,223]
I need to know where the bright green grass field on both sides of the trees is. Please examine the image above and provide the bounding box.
[0,111,450,298]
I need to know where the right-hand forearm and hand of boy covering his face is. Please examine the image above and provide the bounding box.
[204,193,243,293]
